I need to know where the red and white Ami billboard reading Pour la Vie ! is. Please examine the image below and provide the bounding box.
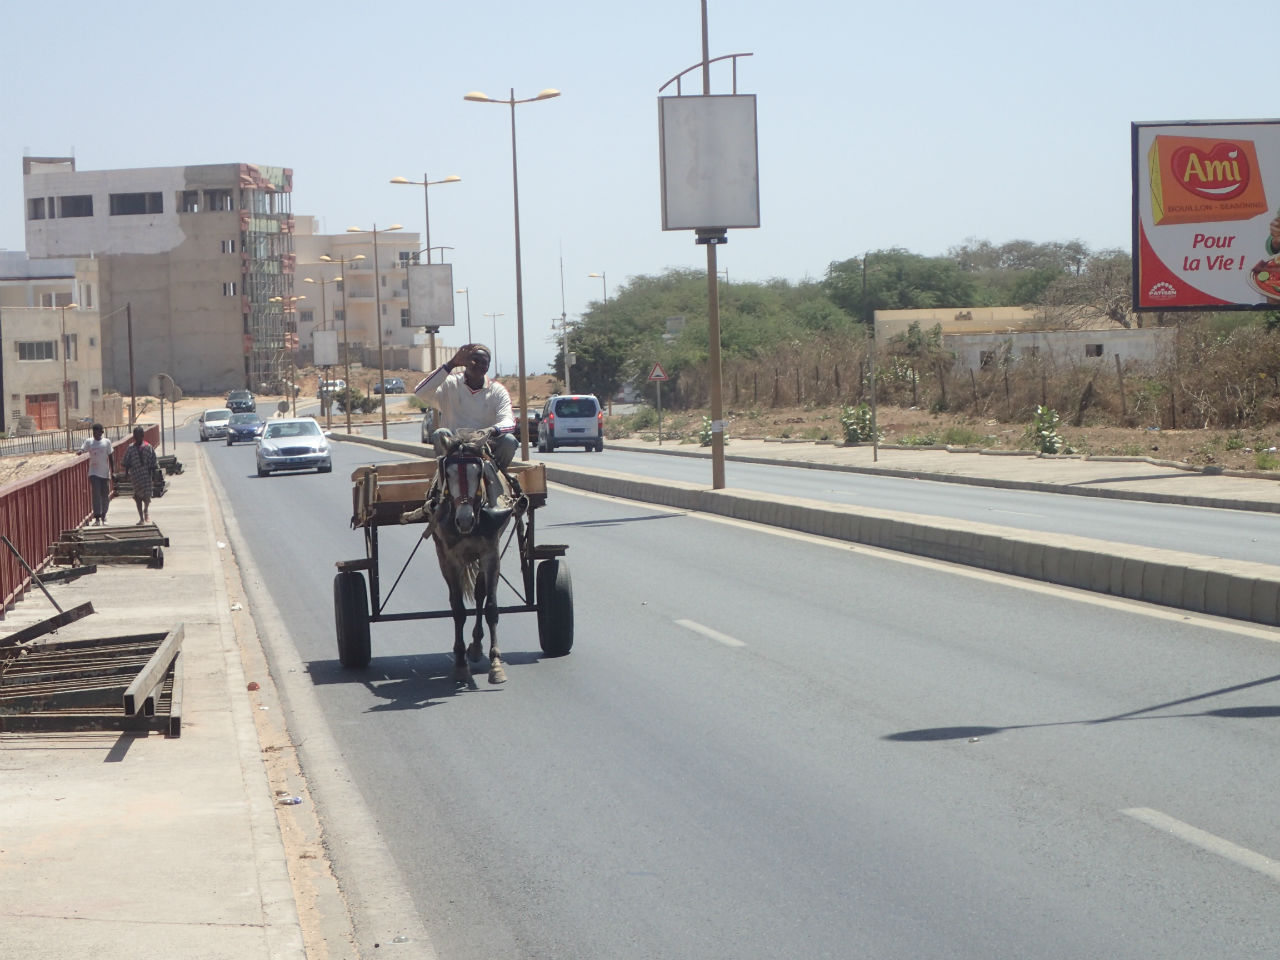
[1132,120,1280,310]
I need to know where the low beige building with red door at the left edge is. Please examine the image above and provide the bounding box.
[0,252,104,433]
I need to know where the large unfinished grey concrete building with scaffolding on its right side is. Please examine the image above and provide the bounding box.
[22,157,296,393]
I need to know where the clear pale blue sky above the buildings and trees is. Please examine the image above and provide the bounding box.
[0,0,1276,374]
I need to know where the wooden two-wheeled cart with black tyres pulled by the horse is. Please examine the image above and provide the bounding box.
[333,460,573,669]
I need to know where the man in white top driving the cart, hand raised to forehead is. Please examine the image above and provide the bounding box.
[413,343,520,470]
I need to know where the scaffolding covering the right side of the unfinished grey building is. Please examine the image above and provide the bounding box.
[239,164,297,393]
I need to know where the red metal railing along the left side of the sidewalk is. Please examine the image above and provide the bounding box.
[0,425,160,617]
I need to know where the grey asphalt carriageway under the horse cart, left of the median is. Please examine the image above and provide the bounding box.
[202,424,1280,960]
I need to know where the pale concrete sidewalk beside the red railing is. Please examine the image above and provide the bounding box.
[0,443,313,960]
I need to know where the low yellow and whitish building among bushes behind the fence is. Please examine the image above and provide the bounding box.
[876,307,1175,372]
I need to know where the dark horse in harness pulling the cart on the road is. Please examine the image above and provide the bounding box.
[422,431,512,689]
